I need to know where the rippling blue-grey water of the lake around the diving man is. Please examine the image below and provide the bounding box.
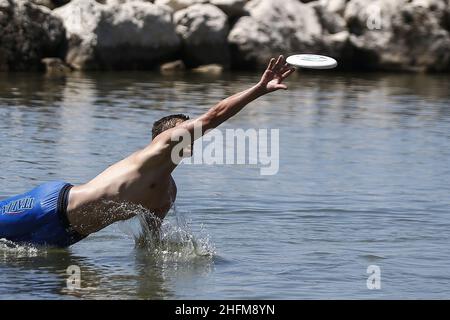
[0,72,450,299]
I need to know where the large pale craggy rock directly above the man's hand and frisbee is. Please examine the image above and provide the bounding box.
[228,0,322,68]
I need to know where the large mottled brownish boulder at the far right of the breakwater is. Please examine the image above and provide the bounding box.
[344,0,450,71]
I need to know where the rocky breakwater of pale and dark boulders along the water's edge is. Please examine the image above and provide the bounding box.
[0,0,450,72]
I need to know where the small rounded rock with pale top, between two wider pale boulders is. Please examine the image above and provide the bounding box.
[174,4,230,67]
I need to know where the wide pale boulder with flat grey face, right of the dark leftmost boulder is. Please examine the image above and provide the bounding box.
[54,0,181,69]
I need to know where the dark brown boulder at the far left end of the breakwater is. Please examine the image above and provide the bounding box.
[0,0,65,71]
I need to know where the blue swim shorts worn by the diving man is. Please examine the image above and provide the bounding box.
[0,181,84,247]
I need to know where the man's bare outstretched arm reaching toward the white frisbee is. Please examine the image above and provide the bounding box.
[144,56,295,161]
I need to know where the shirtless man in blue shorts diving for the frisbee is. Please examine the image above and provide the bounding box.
[0,56,294,247]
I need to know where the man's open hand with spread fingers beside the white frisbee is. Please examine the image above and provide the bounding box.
[259,55,295,93]
